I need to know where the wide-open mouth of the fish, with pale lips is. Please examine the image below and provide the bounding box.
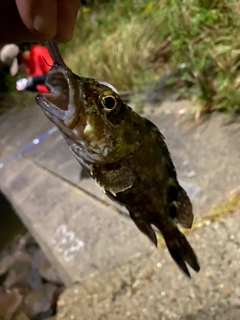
[36,65,84,129]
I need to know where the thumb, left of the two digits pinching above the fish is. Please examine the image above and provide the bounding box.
[16,0,57,39]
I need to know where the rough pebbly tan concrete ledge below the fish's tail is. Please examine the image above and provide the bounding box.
[57,211,240,320]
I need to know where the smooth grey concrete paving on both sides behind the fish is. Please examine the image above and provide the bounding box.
[0,101,240,296]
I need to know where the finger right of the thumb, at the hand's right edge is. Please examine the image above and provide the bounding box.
[55,0,80,42]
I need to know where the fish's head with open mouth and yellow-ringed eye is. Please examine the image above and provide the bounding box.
[36,64,139,163]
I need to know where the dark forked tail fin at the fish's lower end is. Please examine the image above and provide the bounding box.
[162,226,200,278]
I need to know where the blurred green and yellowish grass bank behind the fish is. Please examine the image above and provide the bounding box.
[60,0,240,113]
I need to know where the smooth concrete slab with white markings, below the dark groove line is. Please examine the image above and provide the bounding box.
[0,157,150,285]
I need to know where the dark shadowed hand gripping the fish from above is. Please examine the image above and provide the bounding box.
[0,0,79,43]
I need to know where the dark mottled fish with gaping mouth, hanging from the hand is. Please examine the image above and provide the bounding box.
[36,41,200,278]
